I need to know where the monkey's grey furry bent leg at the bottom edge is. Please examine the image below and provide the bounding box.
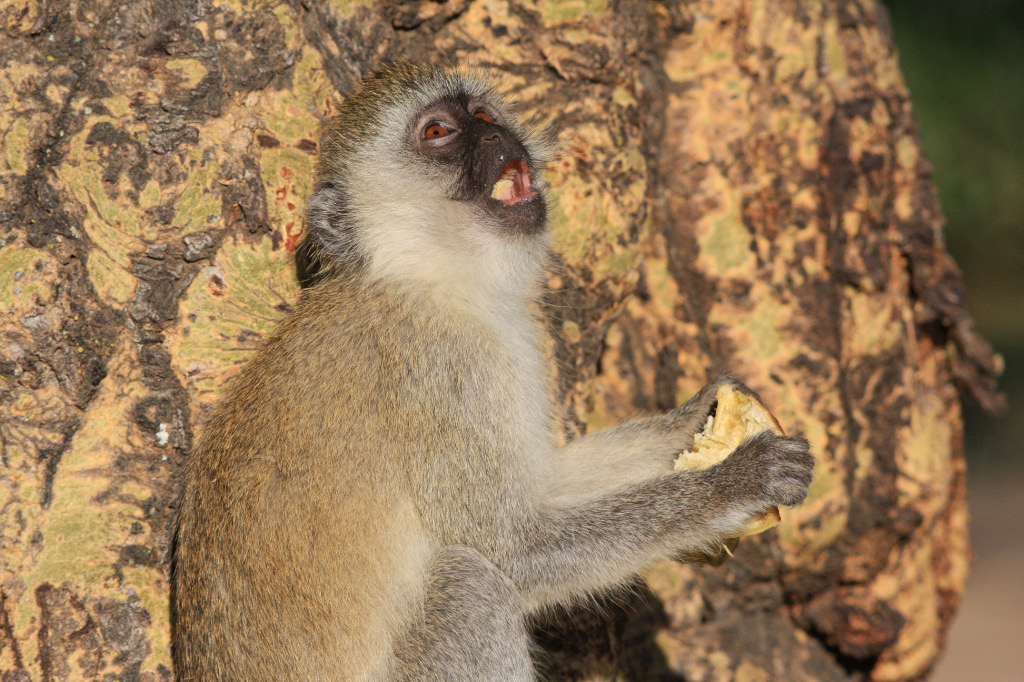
[397,547,536,682]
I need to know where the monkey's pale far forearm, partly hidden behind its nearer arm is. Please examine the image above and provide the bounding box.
[552,375,737,497]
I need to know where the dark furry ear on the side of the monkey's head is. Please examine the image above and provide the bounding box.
[295,182,361,289]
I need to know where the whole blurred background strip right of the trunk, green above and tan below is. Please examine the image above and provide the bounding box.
[887,0,1024,682]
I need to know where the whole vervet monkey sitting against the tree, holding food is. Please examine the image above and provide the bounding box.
[174,63,813,682]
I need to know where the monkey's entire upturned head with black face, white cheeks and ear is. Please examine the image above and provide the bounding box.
[300,62,548,293]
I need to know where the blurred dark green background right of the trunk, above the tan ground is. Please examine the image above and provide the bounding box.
[887,0,1024,466]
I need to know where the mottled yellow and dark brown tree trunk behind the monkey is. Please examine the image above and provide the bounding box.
[0,0,998,682]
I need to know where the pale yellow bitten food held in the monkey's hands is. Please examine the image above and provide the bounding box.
[676,385,782,538]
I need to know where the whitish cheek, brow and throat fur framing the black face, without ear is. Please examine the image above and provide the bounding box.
[342,80,549,302]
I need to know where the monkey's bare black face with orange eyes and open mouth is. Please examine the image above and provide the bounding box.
[412,95,547,235]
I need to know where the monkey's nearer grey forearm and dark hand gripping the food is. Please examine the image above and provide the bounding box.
[498,431,814,608]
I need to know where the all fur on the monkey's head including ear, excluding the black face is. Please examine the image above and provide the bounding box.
[309,67,551,305]
